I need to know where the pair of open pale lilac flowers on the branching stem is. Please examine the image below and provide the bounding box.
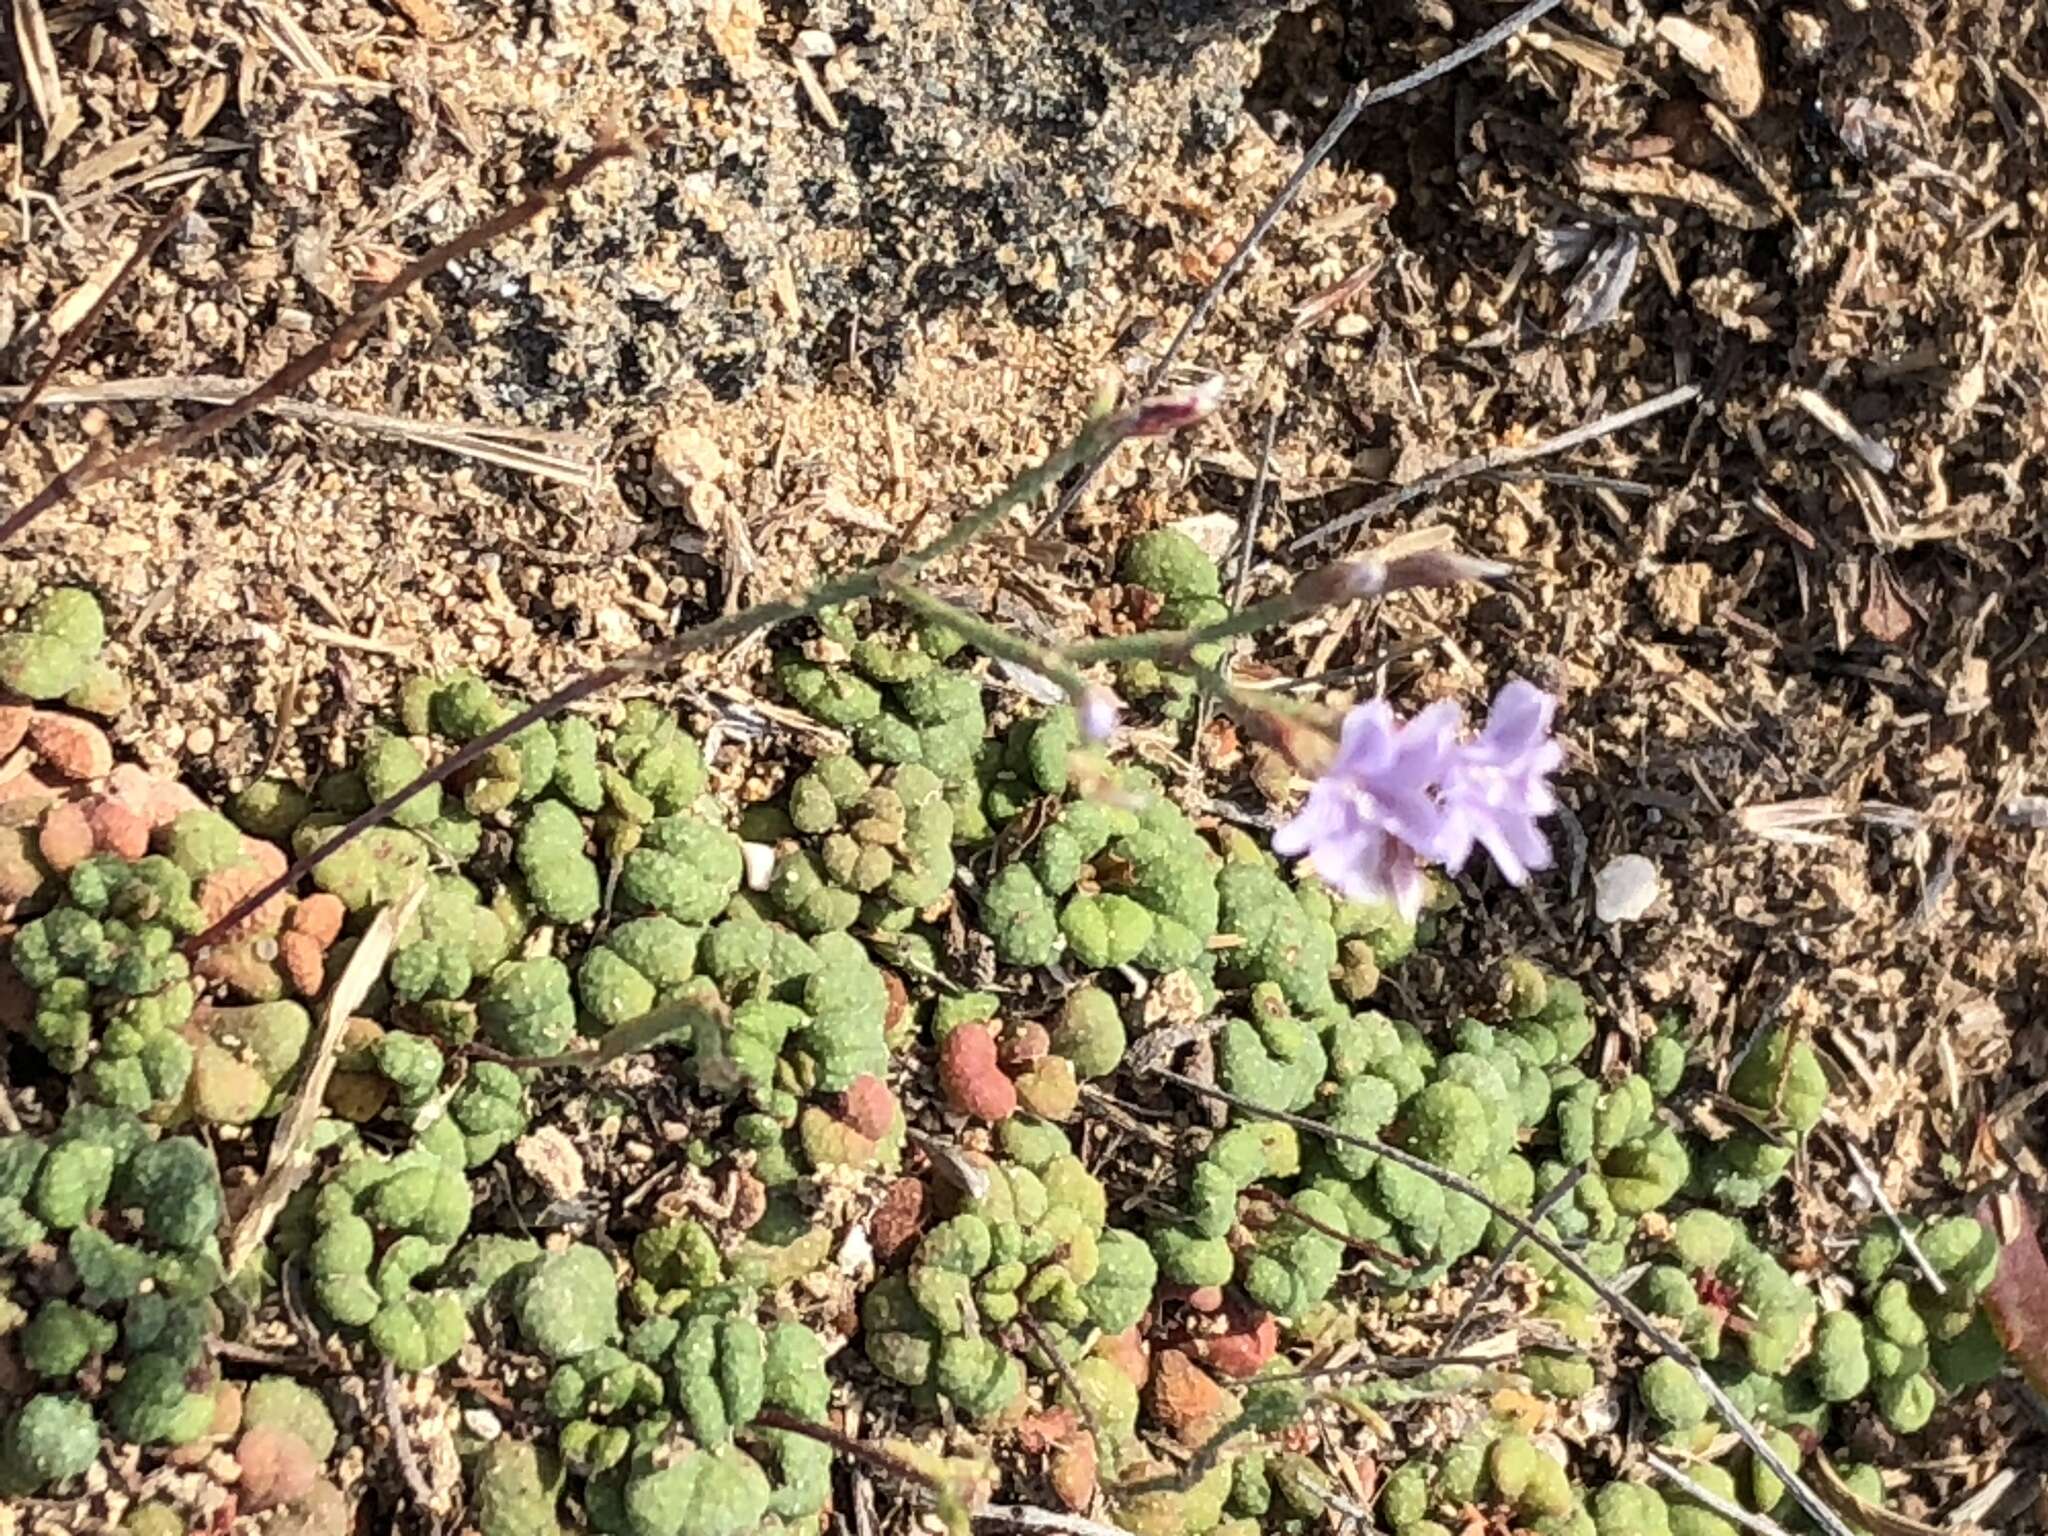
[1274,682,1563,918]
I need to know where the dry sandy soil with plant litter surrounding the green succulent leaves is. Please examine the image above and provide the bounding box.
[0,0,2048,1536]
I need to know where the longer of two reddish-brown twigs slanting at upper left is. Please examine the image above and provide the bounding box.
[0,143,633,545]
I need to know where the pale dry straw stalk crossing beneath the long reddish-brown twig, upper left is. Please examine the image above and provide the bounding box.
[0,375,604,492]
